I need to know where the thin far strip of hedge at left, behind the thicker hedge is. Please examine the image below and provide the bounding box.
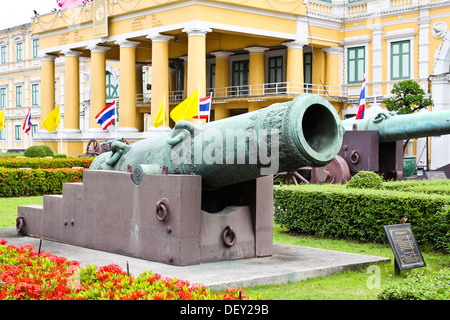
[0,157,95,169]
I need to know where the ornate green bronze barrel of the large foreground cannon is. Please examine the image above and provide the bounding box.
[90,94,344,190]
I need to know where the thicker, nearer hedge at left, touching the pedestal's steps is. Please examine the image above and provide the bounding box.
[0,167,85,197]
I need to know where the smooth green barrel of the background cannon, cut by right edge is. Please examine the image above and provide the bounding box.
[342,111,450,143]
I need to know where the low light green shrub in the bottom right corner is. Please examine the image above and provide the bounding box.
[378,268,450,300]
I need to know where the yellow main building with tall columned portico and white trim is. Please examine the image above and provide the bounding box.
[4,0,450,168]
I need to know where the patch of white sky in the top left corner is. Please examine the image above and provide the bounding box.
[0,0,59,30]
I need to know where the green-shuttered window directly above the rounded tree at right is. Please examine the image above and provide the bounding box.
[391,40,411,80]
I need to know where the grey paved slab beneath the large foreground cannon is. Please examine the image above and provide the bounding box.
[0,229,390,289]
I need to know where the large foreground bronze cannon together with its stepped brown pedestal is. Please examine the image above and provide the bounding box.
[18,95,344,265]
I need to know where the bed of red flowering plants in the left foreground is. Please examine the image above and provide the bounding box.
[0,239,256,300]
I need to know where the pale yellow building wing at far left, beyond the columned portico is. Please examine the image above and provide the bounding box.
[0,23,41,152]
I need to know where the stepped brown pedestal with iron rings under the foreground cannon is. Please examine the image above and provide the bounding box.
[18,170,273,266]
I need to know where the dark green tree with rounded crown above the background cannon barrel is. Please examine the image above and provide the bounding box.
[383,80,433,114]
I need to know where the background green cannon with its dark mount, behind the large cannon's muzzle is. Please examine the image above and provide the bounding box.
[310,111,450,183]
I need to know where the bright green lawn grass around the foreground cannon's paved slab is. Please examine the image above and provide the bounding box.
[0,197,450,300]
